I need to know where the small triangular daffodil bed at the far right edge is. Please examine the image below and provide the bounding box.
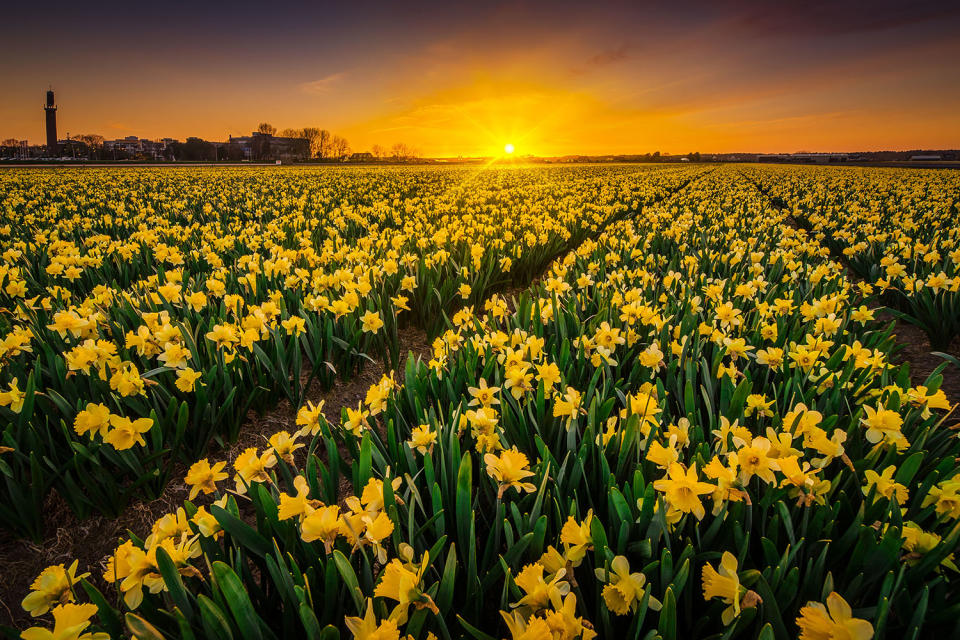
[753,162,960,349]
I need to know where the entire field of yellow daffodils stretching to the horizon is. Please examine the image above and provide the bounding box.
[0,165,960,640]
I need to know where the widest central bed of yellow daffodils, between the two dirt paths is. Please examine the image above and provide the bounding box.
[11,168,960,640]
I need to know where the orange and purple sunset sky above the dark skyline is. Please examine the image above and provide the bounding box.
[0,0,960,156]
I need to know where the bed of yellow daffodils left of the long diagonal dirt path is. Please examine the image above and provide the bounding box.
[0,168,699,538]
